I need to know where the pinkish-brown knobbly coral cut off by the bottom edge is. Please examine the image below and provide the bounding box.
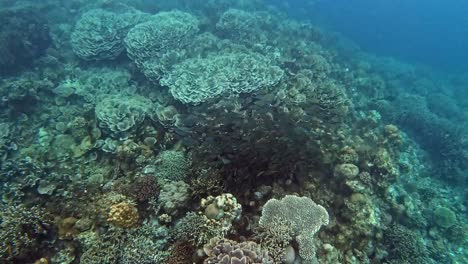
[203,239,273,264]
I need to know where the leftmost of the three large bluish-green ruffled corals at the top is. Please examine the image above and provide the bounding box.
[71,9,144,60]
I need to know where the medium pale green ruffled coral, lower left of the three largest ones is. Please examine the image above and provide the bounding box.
[95,95,152,139]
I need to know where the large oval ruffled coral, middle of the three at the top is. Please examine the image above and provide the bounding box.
[125,11,199,64]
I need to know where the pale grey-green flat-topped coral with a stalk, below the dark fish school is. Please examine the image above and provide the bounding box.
[259,195,329,262]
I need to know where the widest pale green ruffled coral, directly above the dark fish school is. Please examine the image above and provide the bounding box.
[161,52,283,104]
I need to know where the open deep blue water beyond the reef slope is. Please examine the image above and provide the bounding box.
[270,0,468,72]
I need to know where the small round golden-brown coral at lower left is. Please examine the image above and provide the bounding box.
[107,202,140,228]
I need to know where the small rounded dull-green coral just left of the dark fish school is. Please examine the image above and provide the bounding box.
[156,150,191,181]
